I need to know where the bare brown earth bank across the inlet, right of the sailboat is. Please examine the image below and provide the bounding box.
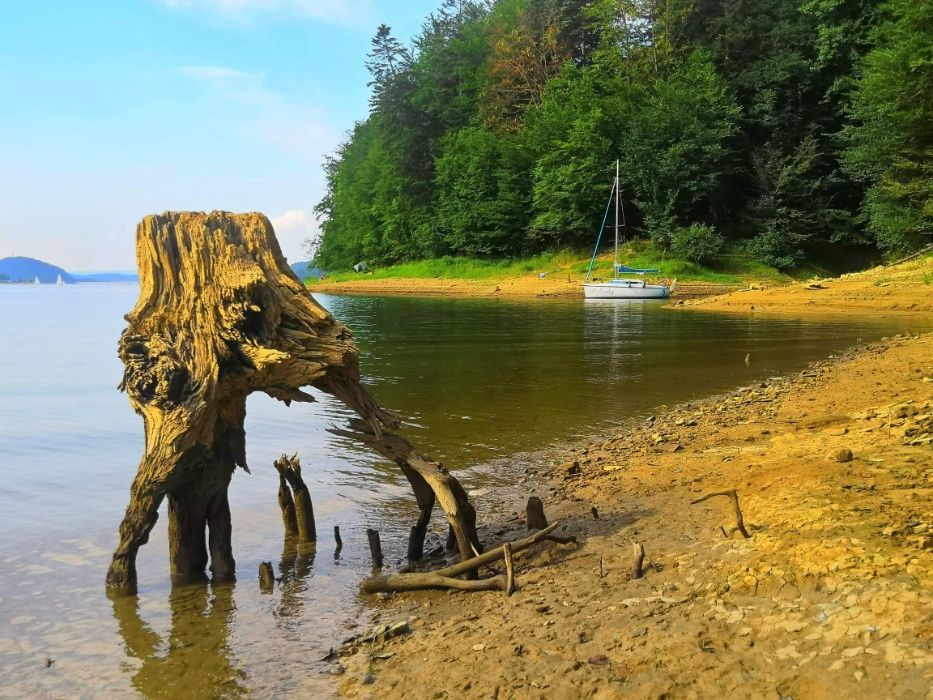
[674,254,933,316]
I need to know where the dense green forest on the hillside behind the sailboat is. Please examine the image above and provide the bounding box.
[315,0,933,269]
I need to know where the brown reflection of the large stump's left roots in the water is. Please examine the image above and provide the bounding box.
[113,584,247,698]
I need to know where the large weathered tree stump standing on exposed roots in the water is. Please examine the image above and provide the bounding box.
[107,212,478,593]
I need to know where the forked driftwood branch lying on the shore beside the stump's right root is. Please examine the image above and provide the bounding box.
[362,523,576,594]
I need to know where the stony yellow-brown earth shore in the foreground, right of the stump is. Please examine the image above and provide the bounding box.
[334,334,933,698]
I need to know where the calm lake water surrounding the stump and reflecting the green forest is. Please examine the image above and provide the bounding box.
[0,285,931,698]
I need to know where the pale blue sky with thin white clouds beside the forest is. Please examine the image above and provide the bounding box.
[0,0,440,272]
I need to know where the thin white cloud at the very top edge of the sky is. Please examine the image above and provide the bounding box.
[160,0,372,27]
